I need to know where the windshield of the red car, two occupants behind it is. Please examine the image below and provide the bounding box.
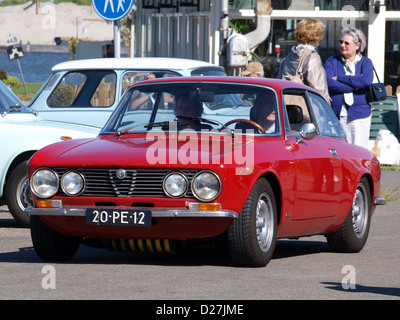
[102,82,279,135]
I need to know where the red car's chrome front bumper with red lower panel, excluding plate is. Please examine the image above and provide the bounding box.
[25,207,239,240]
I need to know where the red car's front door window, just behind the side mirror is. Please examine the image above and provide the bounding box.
[283,93,311,133]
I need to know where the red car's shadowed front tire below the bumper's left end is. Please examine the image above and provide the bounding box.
[31,216,81,261]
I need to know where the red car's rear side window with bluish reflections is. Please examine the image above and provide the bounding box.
[308,92,346,137]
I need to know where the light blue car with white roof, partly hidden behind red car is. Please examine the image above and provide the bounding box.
[28,58,225,128]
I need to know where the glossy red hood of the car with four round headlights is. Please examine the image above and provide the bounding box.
[35,134,254,168]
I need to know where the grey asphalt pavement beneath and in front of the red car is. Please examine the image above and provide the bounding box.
[0,171,400,302]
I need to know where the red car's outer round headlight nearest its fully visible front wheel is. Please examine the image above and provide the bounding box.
[192,171,221,201]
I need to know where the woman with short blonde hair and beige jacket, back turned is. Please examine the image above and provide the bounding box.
[278,18,330,103]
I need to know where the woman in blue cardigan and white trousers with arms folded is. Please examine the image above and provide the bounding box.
[325,28,374,148]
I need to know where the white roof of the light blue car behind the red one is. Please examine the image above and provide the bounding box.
[52,57,224,72]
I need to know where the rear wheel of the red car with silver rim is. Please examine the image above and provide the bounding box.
[326,178,372,253]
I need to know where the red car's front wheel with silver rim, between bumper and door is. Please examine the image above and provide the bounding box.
[228,179,277,267]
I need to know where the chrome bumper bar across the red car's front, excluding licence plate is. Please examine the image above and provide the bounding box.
[25,207,239,219]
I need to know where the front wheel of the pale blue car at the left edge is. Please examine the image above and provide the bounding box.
[4,161,32,227]
